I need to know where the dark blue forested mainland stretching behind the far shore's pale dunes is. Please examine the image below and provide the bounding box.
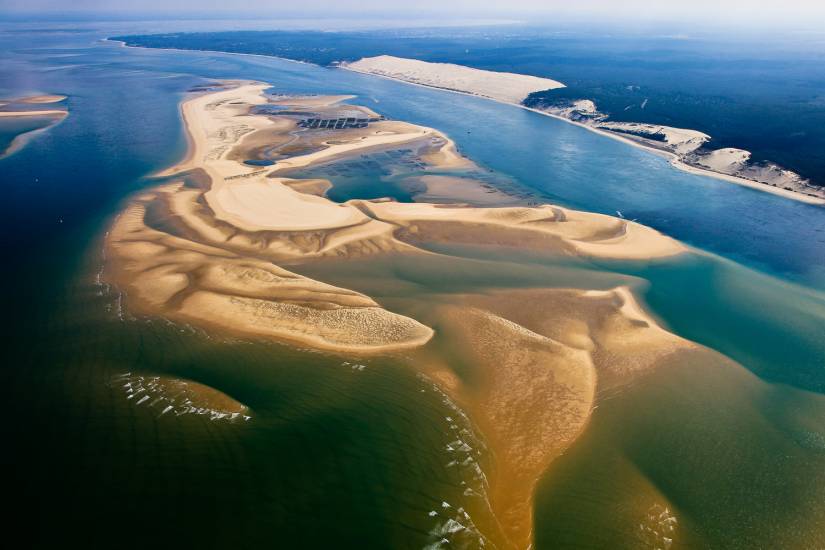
[114,29,825,203]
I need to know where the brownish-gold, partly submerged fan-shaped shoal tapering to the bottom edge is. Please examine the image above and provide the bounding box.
[410,287,695,548]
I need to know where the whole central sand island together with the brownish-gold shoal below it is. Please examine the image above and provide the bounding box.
[106,82,705,548]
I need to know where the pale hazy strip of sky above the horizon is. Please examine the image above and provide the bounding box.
[0,0,825,27]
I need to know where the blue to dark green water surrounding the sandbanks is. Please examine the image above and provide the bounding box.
[0,22,825,548]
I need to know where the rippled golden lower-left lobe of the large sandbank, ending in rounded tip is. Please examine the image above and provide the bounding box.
[108,188,432,352]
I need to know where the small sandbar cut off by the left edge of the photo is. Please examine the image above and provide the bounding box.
[0,94,69,159]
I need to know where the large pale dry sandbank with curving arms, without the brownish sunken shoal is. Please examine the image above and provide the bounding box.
[109,82,685,351]
